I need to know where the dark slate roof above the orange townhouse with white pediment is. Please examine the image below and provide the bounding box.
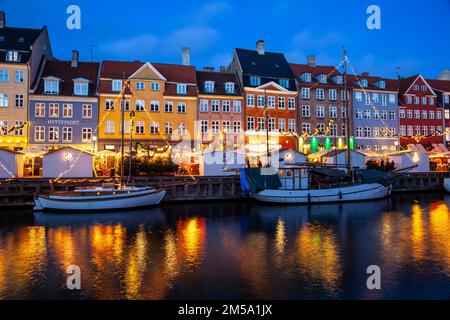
[235,48,295,79]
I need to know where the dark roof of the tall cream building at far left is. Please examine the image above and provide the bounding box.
[0,27,45,63]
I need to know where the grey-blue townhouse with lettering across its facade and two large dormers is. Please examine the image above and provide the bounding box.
[29,51,100,152]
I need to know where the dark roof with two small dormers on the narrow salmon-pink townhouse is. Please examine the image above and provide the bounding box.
[197,71,242,96]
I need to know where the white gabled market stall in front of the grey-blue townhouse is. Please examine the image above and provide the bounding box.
[42,147,94,178]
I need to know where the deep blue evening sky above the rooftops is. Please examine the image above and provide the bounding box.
[0,0,450,78]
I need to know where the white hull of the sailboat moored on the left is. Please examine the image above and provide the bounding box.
[36,188,166,212]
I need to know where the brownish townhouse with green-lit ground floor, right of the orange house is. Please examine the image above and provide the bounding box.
[290,55,350,153]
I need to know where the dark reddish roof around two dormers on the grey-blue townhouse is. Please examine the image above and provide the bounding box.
[34,59,100,96]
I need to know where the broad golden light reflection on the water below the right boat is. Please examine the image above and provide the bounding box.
[297,224,342,292]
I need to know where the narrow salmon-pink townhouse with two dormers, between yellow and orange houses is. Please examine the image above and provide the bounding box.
[197,71,245,149]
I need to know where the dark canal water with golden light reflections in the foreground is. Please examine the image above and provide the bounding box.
[0,193,450,299]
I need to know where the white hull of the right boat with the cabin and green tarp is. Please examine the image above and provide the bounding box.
[252,183,392,204]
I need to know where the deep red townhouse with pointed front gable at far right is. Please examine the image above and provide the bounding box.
[398,74,444,150]
